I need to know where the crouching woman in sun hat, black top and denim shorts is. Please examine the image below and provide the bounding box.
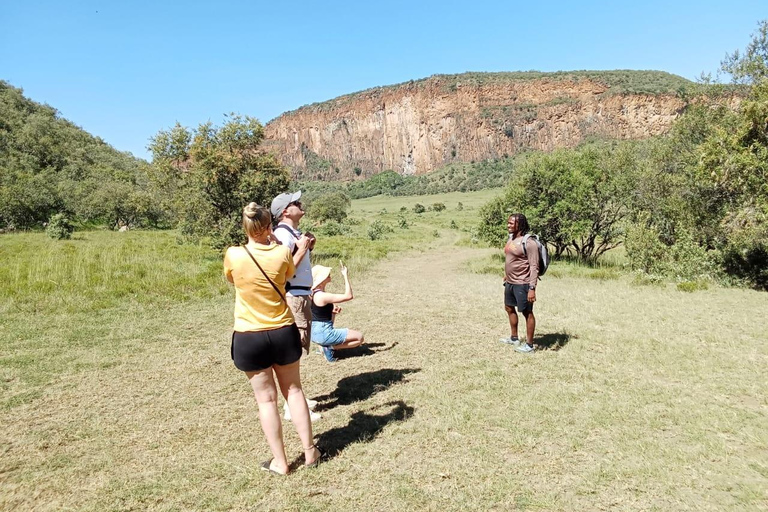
[312,263,365,362]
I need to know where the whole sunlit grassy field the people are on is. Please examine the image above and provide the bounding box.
[0,191,768,511]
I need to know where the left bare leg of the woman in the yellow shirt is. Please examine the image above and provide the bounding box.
[245,368,288,473]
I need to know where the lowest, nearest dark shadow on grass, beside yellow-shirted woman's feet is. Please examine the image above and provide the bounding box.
[317,400,414,457]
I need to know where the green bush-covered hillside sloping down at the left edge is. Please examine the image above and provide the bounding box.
[0,80,161,230]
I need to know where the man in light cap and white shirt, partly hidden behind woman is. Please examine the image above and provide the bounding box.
[270,190,320,421]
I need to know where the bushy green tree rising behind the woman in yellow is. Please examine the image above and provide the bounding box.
[149,114,290,248]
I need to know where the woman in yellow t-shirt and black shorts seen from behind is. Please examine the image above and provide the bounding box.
[224,203,325,475]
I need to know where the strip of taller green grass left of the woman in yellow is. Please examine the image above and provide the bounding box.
[0,231,228,313]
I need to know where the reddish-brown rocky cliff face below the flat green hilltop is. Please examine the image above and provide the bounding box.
[265,75,684,180]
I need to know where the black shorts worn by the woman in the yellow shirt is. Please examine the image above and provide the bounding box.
[231,324,301,372]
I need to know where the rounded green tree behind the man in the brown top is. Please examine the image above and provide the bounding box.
[479,143,637,259]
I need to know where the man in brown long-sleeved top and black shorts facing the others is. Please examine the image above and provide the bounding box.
[500,213,539,354]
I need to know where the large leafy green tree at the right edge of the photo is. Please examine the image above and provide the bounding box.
[627,21,768,289]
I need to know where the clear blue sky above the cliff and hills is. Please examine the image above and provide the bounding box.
[0,0,768,158]
